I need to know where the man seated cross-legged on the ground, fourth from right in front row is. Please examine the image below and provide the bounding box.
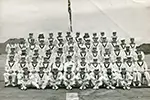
[76,67,90,90]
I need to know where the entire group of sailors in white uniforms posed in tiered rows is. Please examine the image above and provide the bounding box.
[4,32,150,90]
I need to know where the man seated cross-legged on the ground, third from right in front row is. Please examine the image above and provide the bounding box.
[90,68,104,89]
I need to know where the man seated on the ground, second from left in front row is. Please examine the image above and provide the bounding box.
[37,66,49,89]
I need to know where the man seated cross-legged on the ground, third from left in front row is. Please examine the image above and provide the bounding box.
[49,67,63,90]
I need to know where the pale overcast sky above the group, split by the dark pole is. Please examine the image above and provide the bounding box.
[0,0,150,42]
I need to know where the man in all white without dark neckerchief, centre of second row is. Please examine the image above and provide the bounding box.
[64,56,76,72]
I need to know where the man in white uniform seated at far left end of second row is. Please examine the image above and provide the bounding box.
[4,55,18,86]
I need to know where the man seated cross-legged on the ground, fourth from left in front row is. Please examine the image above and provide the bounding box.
[63,65,75,90]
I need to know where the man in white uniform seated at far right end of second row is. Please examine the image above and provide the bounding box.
[135,56,150,86]
